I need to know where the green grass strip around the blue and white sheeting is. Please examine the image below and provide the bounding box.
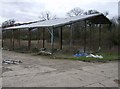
[51,52,118,62]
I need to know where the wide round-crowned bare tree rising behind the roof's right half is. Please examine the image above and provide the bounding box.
[67,7,84,17]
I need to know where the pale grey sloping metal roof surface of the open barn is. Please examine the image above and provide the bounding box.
[5,14,110,29]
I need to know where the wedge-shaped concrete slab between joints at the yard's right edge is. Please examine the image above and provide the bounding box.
[82,62,118,77]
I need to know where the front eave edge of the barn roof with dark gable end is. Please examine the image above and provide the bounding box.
[4,14,112,30]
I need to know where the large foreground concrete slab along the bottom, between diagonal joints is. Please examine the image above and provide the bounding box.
[3,69,106,87]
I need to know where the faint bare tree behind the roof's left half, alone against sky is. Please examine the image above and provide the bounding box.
[39,11,57,20]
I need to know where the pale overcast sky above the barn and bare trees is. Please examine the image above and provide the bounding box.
[0,0,119,23]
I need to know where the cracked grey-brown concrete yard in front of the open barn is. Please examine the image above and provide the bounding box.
[2,50,118,87]
